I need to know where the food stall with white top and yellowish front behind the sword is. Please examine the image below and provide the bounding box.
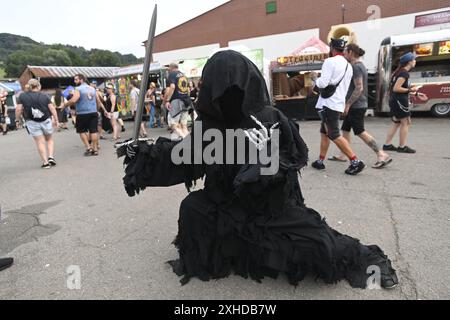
[113,63,168,119]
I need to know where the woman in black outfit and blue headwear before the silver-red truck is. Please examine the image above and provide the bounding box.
[383,52,428,154]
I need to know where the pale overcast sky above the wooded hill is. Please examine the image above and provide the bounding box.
[0,0,228,57]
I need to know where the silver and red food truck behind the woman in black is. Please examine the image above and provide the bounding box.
[376,29,450,117]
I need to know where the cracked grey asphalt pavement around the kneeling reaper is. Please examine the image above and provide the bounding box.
[0,118,450,300]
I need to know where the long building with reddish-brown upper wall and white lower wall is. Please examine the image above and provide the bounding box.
[154,0,450,79]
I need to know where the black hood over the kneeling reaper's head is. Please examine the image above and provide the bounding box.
[197,50,270,121]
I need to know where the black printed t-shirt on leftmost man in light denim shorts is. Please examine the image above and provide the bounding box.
[17,92,51,122]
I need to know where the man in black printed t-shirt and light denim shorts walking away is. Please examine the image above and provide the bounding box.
[16,79,59,169]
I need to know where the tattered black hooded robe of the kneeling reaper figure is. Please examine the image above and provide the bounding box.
[120,51,397,288]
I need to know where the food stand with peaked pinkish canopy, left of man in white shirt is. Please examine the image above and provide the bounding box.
[270,38,330,120]
